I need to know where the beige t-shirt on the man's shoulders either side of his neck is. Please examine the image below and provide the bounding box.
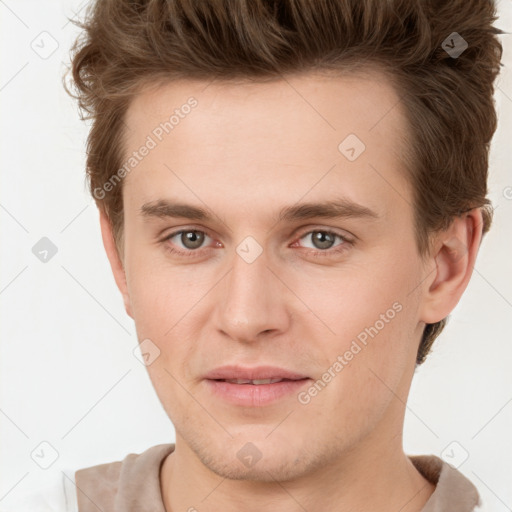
[75,444,481,512]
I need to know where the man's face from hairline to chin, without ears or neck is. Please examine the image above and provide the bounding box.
[118,71,427,481]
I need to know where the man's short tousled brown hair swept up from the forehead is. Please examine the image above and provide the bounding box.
[64,0,504,364]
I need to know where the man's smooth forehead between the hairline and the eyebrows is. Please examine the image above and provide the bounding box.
[121,72,408,222]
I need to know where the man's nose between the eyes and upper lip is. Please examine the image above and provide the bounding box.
[214,240,293,343]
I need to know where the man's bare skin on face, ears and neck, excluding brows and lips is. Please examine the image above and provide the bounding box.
[101,72,482,512]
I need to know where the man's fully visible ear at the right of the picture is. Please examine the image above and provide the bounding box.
[420,208,483,324]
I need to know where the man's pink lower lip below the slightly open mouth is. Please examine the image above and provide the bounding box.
[205,378,311,407]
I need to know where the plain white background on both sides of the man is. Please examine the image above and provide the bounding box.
[0,0,512,512]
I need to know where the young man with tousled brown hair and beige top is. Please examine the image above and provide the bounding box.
[55,0,501,512]
